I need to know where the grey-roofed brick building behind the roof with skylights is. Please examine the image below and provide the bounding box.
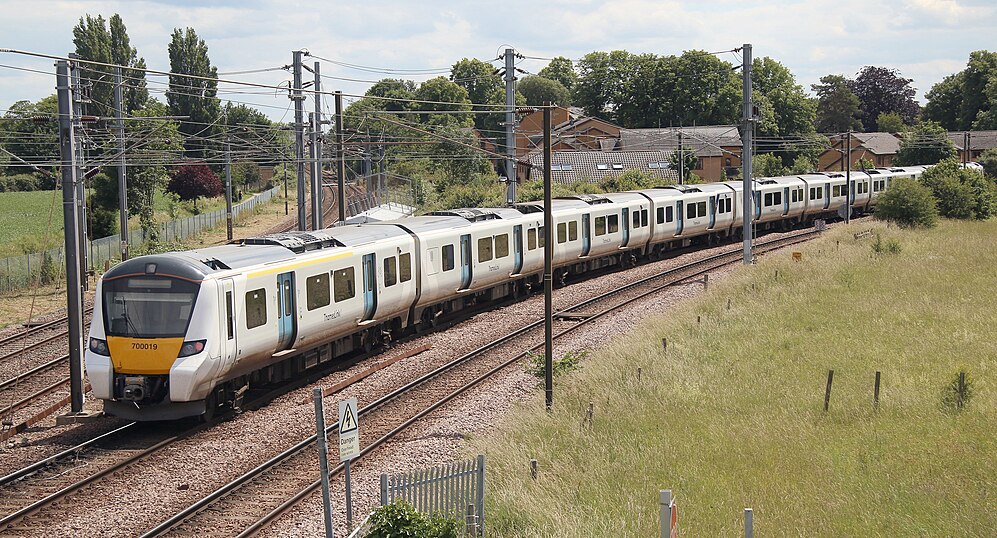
[617,125,742,181]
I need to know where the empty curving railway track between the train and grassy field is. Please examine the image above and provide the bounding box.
[143,228,816,538]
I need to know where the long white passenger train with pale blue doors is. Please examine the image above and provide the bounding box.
[85,167,924,420]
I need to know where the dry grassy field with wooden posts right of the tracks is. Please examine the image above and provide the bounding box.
[470,221,997,537]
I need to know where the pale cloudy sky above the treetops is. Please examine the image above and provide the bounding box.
[0,0,997,120]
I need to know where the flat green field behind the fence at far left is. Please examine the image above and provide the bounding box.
[0,191,62,257]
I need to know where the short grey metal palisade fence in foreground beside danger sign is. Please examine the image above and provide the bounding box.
[381,455,485,536]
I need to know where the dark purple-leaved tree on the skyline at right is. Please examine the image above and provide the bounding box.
[849,65,920,127]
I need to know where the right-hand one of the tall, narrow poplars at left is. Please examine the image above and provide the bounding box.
[166,27,221,159]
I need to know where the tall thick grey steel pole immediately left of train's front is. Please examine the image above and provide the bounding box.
[55,60,83,413]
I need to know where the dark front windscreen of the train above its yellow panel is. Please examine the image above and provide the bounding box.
[103,275,200,338]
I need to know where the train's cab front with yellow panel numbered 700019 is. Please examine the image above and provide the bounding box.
[86,256,214,420]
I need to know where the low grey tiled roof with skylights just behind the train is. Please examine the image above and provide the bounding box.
[517,150,678,184]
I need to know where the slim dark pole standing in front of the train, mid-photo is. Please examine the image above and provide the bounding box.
[544,101,554,412]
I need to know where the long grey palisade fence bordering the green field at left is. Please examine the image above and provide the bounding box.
[0,187,277,292]
